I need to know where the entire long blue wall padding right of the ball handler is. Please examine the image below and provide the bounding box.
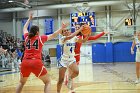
[92,42,136,63]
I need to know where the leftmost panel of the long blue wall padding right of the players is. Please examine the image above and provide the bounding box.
[92,43,106,63]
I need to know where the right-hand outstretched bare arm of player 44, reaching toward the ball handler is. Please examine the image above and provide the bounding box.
[48,23,68,40]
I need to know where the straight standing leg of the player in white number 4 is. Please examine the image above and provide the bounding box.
[57,67,67,93]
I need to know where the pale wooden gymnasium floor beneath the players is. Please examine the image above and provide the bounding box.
[0,60,140,93]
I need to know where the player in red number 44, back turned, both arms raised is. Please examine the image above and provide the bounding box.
[16,14,66,93]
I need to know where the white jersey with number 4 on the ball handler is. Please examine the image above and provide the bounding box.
[61,36,78,56]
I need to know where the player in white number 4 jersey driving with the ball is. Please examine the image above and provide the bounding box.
[57,26,88,93]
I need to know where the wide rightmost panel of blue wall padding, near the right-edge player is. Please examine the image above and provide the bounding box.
[113,42,135,62]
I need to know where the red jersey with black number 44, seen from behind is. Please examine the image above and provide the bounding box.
[23,34,48,59]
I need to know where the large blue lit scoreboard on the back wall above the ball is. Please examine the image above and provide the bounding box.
[70,12,96,32]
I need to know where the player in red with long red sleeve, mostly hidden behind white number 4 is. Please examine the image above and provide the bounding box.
[68,24,108,93]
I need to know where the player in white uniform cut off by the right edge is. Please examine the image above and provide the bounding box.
[131,31,140,84]
